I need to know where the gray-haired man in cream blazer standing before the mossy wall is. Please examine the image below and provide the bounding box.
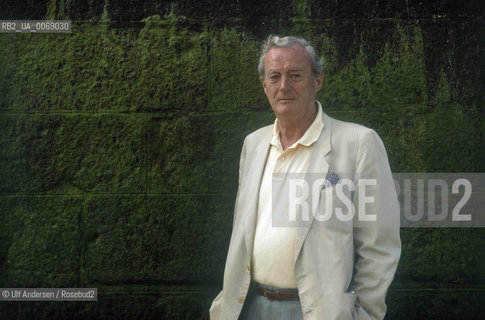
[210,36,401,320]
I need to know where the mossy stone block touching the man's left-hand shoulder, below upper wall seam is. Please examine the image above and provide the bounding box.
[148,113,273,194]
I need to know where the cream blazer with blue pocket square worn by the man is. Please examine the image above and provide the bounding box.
[210,113,401,320]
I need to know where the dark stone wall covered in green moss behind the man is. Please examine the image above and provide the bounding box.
[0,0,485,319]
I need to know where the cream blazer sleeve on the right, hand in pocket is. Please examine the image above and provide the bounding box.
[351,129,401,319]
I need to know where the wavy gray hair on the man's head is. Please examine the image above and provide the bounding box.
[258,35,324,79]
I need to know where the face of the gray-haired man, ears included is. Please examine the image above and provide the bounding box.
[260,45,324,120]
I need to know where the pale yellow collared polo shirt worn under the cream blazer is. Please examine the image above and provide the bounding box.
[252,101,323,289]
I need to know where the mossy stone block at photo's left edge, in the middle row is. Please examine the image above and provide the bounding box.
[0,114,146,194]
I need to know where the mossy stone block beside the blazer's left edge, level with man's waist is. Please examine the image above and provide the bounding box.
[83,195,234,284]
